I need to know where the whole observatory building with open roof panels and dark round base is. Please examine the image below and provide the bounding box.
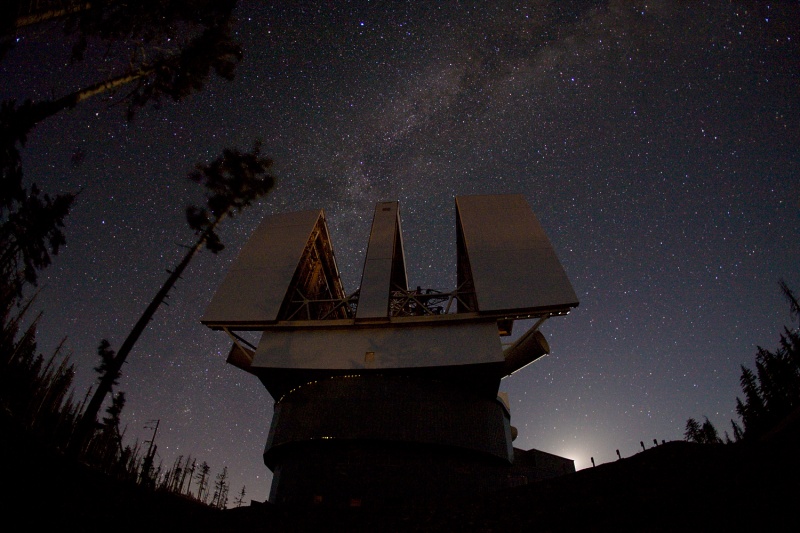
[202,195,578,507]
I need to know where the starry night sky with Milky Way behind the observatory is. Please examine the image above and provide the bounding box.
[0,0,800,500]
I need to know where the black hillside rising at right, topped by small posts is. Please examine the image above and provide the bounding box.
[444,441,800,531]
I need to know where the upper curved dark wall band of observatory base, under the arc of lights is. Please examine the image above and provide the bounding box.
[264,374,513,467]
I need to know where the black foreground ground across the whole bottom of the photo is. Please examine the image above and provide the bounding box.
[0,416,800,532]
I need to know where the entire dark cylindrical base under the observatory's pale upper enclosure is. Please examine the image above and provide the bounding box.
[264,374,514,507]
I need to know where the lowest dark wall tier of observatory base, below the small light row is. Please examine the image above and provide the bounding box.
[270,441,510,508]
